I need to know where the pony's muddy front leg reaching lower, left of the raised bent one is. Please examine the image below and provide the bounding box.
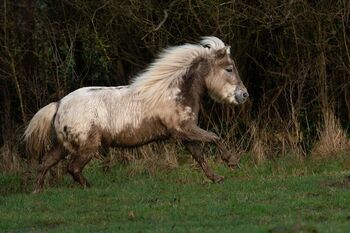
[183,141,224,183]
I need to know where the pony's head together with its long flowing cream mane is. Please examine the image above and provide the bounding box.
[131,36,248,108]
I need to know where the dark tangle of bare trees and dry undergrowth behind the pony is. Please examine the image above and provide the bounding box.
[0,0,350,171]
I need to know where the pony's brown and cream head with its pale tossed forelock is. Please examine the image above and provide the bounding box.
[201,37,249,104]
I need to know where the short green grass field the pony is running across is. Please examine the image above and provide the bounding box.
[0,155,350,233]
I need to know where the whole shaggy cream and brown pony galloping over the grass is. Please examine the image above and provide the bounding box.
[24,37,248,192]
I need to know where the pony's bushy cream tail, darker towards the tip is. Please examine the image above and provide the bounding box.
[23,102,58,160]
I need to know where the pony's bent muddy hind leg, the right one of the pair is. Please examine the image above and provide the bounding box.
[68,153,92,188]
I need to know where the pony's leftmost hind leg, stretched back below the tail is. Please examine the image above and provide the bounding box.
[33,145,65,193]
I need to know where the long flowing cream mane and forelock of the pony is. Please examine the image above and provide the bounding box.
[130,36,225,107]
